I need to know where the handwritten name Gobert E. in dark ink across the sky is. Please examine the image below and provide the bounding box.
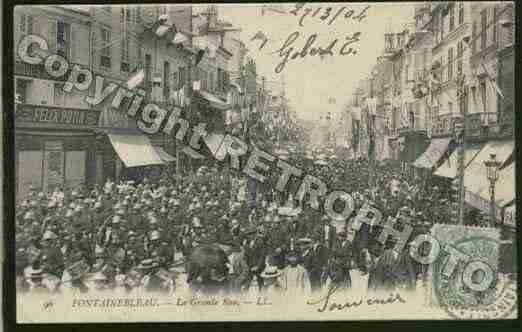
[275,31,361,74]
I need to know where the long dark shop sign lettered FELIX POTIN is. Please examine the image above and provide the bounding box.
[16,104,99,126]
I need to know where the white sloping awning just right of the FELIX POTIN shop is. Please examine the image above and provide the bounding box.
[107,133,163,167]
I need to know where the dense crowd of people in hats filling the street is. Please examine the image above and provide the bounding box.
[16,159,488,294]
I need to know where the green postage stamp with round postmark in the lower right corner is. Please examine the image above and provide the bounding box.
[424,225,517,319]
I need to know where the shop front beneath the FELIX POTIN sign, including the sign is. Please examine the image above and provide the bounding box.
[15,104,99,198]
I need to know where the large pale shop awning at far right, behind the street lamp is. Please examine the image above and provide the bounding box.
[464,141,515,208]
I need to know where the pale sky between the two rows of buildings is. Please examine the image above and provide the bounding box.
[207,3,413,120]
